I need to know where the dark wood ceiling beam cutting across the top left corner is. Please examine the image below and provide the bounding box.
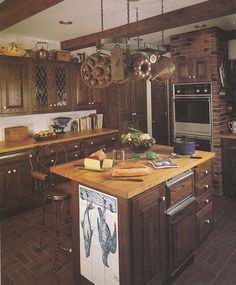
[0,0,64,31]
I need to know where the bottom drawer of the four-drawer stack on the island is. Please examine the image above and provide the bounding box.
[196,202,214,242]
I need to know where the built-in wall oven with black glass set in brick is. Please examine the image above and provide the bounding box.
[173,82,212,151]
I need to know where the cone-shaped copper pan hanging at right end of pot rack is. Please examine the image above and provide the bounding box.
[150,56,175,81]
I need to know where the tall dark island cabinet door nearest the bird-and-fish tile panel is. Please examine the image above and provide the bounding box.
[131,185,166,285]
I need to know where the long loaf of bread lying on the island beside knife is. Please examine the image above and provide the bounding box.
[110,164,152,177]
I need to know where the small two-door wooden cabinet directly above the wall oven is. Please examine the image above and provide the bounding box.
[175,56,211,83]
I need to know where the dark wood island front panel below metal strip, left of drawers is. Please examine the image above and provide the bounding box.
[167,198,197,276]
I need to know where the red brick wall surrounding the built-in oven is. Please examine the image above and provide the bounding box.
[170,27,231,195]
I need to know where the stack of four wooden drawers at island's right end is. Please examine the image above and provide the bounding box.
[194,160,214,243]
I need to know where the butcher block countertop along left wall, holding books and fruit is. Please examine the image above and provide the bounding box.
[0,129,118,155]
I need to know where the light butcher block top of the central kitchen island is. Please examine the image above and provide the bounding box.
[51,145,215,199]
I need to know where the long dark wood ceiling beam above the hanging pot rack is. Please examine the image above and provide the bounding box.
[61,0,236,50]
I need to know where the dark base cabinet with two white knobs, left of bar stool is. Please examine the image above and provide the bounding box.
[0,152,39,218]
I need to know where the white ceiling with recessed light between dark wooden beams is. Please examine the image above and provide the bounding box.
[0,0,236,48]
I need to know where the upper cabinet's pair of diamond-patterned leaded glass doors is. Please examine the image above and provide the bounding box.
[32,60,71,112]
